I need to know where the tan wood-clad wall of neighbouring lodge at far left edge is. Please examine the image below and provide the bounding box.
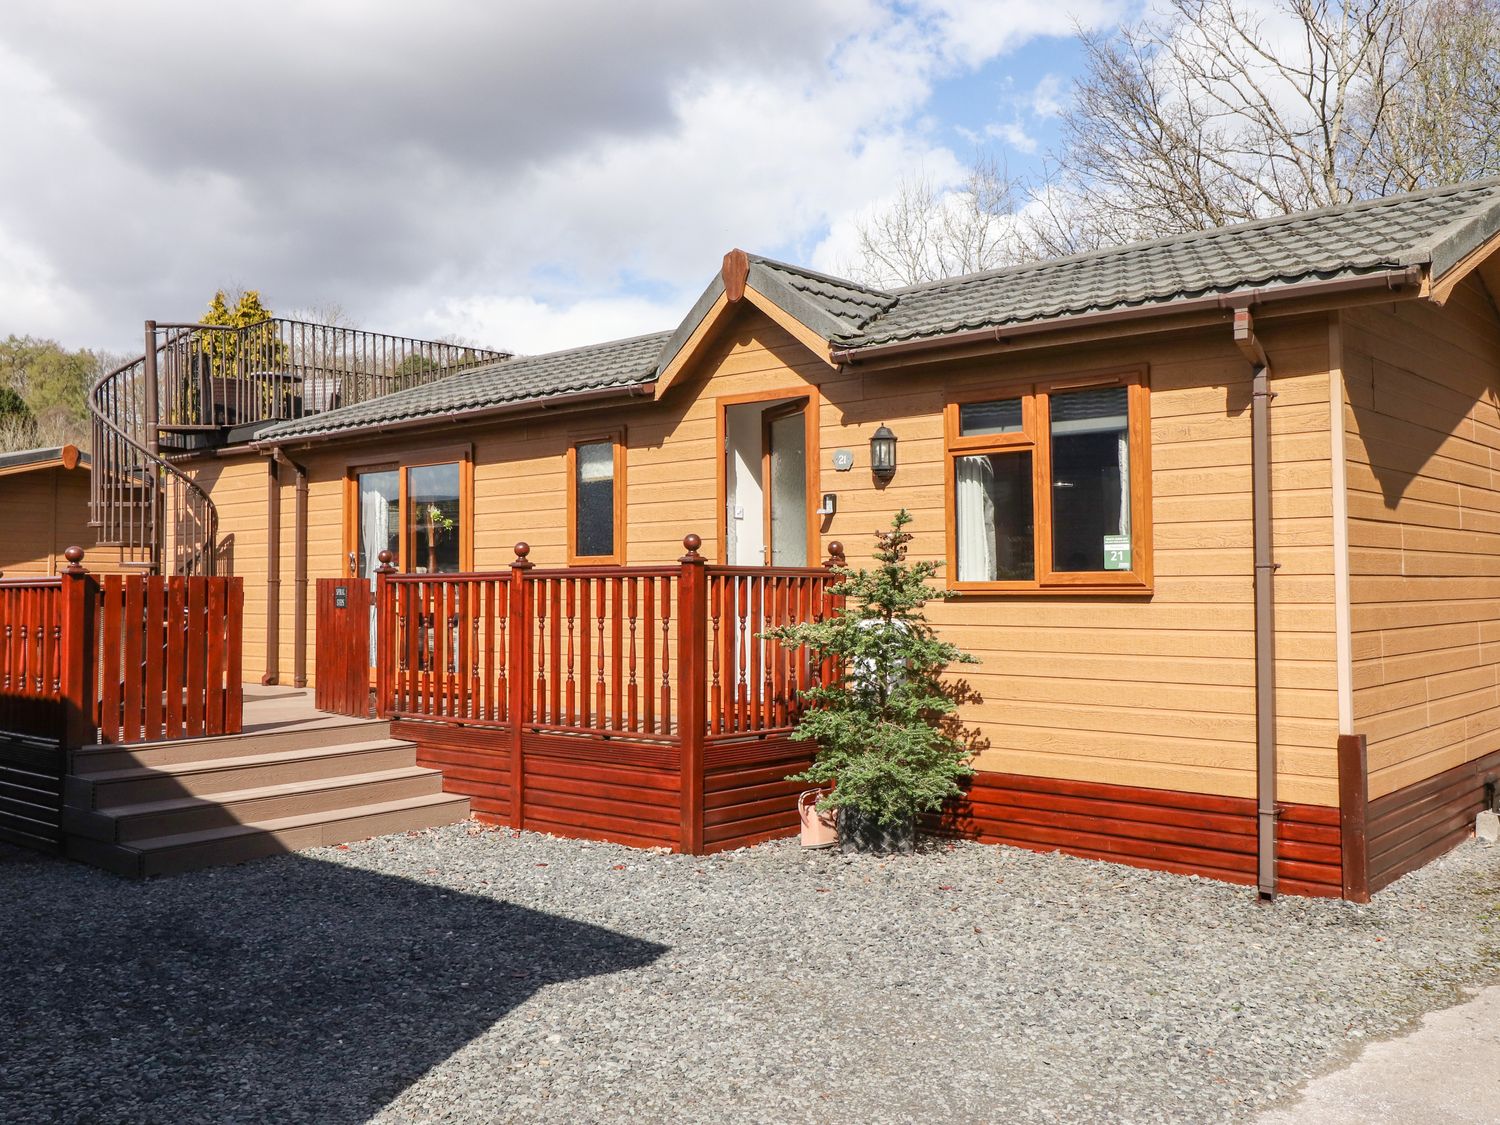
[0,464,122,578]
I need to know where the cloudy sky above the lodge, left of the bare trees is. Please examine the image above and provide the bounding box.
[0,0,1128,353]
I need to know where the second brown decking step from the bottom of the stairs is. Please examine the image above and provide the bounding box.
[63,765,443,843]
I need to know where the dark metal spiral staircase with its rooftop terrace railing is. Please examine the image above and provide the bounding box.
[89,318,509,575]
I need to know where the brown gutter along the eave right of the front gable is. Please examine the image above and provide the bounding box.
[830,266,1424,363]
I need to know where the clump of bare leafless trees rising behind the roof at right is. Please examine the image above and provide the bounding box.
[858,0,1500,282]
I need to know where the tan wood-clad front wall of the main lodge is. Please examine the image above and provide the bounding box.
[194,309,1338,807]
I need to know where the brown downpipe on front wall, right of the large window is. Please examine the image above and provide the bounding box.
[1235,309,1277,902]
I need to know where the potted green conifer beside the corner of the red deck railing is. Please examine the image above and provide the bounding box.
[767,509,977,852]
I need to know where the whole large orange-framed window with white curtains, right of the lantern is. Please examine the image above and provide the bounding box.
[944,372,1152,593]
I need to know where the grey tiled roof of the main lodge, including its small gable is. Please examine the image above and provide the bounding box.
[257,179,1500,441]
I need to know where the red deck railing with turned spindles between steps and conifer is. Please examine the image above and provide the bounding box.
[375,536,843,744]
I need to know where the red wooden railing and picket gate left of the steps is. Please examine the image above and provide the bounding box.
[0,548,243,749]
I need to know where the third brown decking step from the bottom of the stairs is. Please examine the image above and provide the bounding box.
[65,738,417,810]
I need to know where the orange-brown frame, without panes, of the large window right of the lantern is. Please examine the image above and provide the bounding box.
[944,368,1155,594]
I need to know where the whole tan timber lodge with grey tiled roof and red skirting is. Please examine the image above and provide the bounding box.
[17,180,1500,899]
